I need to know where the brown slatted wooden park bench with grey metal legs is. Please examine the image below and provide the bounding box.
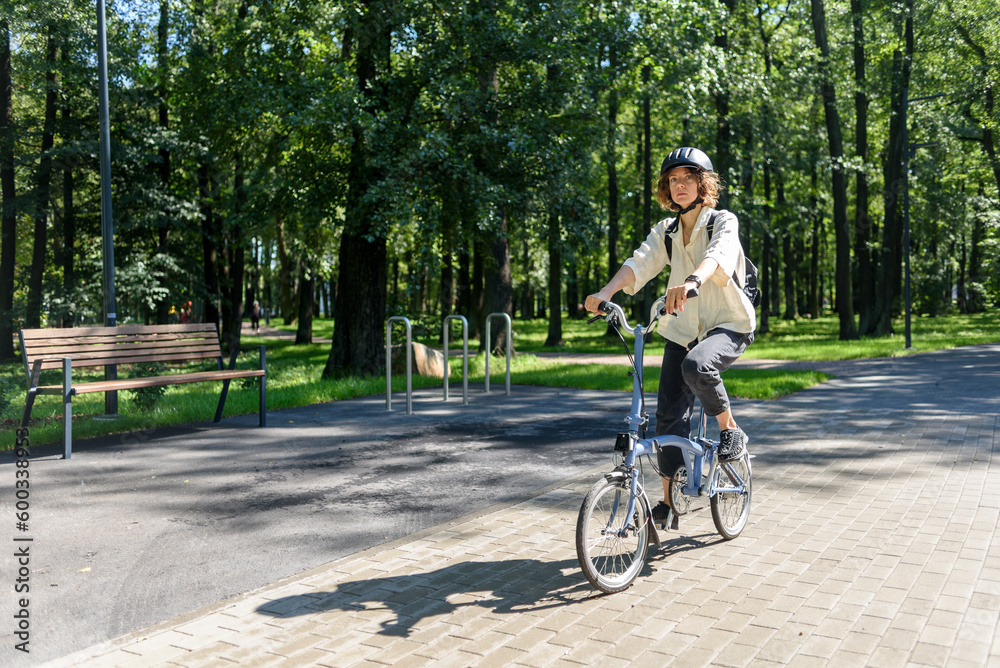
[20,324,267,459]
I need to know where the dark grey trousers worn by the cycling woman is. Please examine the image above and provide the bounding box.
[655,327,753,477]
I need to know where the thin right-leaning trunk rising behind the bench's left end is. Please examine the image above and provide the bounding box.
[25,30,58,328]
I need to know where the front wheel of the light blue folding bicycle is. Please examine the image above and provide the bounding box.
[576,479,649,594]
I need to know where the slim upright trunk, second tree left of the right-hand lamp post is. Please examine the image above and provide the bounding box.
[851,0,875,334]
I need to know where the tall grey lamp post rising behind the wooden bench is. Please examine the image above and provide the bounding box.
[97,0,118,416]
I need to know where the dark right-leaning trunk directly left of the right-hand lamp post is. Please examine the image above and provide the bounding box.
[872,0,913,336]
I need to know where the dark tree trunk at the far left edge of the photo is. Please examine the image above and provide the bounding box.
[0,18,17,360]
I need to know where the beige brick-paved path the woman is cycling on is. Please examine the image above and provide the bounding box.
[27,345,1000,667]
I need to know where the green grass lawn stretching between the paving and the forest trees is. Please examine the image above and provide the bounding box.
[0,313,1000,449]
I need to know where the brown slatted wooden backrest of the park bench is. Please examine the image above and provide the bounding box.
[20,324,222,373]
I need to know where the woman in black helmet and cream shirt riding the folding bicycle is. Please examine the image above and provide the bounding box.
[585,147,757,520]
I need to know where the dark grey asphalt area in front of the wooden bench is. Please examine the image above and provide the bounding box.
[0,380,640,665]
